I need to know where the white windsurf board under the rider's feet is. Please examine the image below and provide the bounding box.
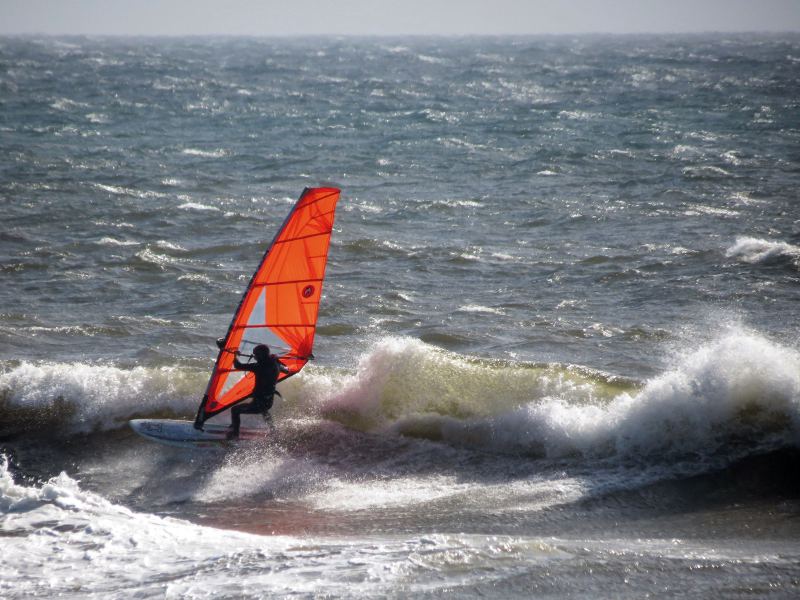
[128,419,270,448]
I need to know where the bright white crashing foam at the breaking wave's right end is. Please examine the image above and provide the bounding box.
[476,329,800,460]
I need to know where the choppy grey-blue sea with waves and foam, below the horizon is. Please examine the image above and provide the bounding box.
[0,34,800,598]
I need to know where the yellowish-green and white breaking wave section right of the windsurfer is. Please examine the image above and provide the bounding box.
[298,329,800,459]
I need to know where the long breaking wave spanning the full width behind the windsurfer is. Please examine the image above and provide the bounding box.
[0,328,800,460]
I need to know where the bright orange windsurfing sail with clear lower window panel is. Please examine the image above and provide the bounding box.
[195,188,340,428]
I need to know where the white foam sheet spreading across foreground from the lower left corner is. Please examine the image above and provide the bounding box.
[0,459,570,599]
